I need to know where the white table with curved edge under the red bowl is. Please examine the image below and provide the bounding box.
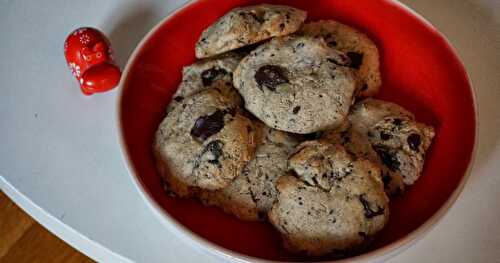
[0,0,500,262]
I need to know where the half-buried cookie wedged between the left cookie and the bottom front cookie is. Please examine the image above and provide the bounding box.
[200,124,297,220]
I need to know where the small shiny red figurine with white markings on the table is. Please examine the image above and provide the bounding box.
[64,27,121,95]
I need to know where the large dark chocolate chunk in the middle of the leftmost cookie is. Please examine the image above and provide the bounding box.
[191,110,227,141]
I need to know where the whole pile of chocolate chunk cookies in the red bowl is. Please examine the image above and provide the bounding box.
[153,4,434,256]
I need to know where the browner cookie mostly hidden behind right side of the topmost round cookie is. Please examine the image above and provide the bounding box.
[300,20,382,97]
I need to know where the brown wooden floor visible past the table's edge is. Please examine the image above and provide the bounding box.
[0,190,94,263]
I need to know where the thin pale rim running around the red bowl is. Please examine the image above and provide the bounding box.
[115,0,479,263]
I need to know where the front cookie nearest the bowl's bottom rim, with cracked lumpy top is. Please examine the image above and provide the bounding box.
[269,141,389,256]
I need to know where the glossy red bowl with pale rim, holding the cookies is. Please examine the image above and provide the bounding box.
[118,0,476,261]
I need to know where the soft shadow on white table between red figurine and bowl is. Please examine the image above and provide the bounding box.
[98,1,162,70]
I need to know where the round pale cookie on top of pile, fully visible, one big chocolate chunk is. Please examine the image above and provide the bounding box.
[233,37,356,134]
